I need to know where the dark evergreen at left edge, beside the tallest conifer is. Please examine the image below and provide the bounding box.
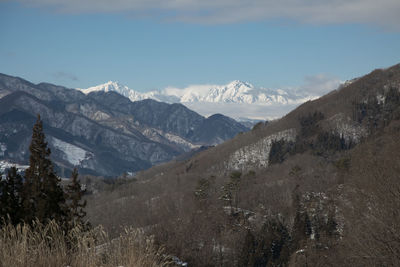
[0,167,22,225]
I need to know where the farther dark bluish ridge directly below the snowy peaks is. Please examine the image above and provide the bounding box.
[89,92,248,145]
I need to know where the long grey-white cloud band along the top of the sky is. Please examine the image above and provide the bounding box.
[15,0,400,30]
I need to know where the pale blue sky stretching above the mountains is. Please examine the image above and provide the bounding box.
[0,0,400,91]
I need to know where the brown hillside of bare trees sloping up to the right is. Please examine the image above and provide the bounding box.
[88,65,400,266]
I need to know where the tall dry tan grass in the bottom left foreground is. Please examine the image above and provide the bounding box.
[0,222,172,267]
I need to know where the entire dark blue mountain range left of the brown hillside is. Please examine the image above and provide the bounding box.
[0,74,248,176]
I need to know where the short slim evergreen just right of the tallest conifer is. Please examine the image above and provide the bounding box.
[66,168,86,225]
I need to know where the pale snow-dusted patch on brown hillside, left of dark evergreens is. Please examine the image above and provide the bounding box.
[226,129,296,170]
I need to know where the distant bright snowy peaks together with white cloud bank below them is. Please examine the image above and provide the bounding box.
[78,80,317,120]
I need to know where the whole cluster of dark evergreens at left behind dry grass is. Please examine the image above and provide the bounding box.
[0,115,89,230]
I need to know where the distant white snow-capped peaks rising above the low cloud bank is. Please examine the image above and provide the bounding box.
[79,80,315,105]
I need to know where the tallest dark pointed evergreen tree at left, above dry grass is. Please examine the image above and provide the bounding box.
[23,115,67,224]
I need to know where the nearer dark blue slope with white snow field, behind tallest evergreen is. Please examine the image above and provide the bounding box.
[0,92,173,177]
